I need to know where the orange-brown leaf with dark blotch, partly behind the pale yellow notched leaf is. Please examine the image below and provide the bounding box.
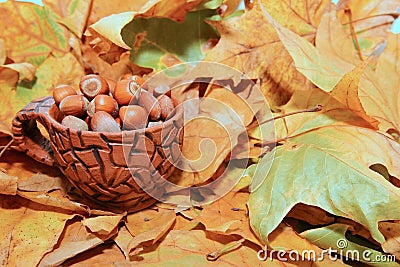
[205,1,329,107]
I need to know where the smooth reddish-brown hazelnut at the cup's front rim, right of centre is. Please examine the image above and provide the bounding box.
[119,105,147,130]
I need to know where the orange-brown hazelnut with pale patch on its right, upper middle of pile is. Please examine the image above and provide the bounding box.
[114,80,141,106]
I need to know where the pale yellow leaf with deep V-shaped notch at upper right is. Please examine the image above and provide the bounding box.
[264,5,359,92]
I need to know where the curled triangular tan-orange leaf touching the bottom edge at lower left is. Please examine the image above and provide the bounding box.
[39,221,117,266]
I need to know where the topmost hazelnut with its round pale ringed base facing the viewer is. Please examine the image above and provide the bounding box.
[79,74,110,100]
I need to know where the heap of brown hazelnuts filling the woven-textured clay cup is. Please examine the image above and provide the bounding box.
[53,74,175,132]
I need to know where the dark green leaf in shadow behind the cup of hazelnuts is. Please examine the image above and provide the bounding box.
[121,10,218,70]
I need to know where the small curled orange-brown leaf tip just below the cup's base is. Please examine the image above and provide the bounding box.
[82,214,125,236]
